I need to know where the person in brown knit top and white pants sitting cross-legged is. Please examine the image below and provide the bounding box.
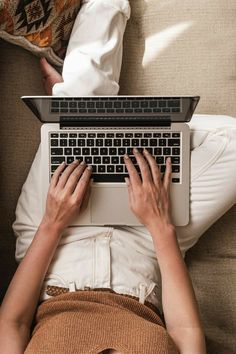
[0,0,236,354]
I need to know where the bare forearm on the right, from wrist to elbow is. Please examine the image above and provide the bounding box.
[152,227,205,354]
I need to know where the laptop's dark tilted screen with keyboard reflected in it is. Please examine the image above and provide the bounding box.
[22,96,200,126]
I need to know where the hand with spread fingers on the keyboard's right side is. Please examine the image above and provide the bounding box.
[124,149,173,230]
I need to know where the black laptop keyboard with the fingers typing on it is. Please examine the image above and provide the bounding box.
[50,130,181,183]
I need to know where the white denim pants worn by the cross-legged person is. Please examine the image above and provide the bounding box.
[13,0,236,308]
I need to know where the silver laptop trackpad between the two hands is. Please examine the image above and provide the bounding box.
[91,186,137,225]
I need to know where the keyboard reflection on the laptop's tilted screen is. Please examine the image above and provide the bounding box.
[50,96,181,114]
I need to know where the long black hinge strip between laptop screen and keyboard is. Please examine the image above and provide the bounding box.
[60,115,171,128]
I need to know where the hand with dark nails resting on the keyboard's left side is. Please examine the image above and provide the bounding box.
[42,160,92,232]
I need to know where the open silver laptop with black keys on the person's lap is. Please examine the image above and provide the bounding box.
[22,96,200,226]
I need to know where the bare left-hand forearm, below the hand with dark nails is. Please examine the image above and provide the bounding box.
[0,224,61,327]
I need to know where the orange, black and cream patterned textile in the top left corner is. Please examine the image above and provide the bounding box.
[0,0,81,66]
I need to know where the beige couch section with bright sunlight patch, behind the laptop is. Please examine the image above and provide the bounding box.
[120,0,236,117]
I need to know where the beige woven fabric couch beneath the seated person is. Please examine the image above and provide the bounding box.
[0,0,236,354]
